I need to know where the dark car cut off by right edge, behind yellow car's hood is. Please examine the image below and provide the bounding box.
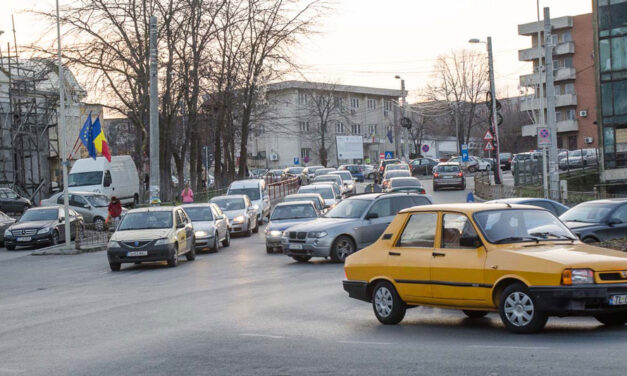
[560,198,627,243]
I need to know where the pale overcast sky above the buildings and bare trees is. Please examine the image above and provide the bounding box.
[0,0,592,100]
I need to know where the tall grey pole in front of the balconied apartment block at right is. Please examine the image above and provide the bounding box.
[544,7,560,200]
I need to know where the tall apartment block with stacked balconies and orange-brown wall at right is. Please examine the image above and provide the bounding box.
[518,13,598,150]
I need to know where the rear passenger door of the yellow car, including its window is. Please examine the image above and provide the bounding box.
[386,212,438,301]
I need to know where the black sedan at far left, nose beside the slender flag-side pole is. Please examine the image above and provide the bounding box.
[4,206,83,251]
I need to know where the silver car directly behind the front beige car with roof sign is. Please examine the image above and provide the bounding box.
[181,203,231,252]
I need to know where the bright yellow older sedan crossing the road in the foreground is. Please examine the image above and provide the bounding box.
[344,204,627,333]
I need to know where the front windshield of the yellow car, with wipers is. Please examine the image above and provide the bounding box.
[474,209,575,244]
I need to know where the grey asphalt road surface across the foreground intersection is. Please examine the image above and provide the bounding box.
[0,181,627,376]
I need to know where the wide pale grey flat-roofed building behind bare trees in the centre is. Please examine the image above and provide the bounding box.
[248,81,402,168]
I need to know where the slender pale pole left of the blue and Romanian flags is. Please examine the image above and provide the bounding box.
[57,0,72,248]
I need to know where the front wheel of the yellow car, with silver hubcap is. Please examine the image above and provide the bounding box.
[499,283,548,334]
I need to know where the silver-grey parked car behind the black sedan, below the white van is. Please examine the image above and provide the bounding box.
[40,191,128,231]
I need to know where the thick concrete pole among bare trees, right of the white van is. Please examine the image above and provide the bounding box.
[150,16,161,204]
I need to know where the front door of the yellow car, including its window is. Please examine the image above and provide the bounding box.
[431,212,491,302]
